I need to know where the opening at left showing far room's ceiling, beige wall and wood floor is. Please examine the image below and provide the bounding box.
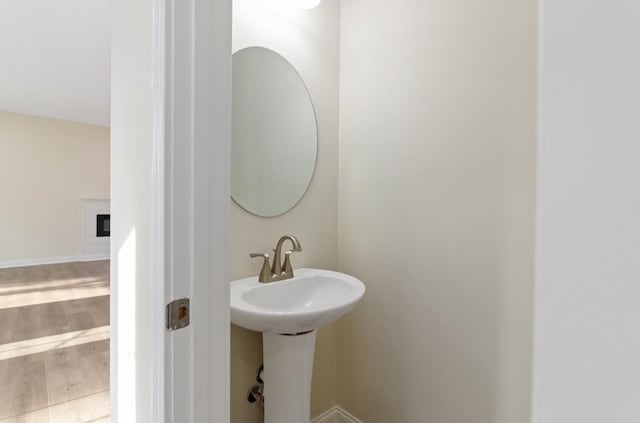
[0,0,111,423]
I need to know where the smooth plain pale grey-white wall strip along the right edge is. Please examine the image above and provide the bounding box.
[534,0,640,423]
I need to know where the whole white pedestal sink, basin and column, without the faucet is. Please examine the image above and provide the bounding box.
[231,269,365,423]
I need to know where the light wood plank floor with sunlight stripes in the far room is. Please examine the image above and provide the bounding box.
[0,261,109,423]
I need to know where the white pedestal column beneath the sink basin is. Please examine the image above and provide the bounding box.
[262,331,316,423]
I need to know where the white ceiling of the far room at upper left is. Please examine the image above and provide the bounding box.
[0,0,111,126]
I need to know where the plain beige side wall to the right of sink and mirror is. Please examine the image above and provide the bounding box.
[338,0,537,423]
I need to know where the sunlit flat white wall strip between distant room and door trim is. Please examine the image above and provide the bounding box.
[110,0,155,423]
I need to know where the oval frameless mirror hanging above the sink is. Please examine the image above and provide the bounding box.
[231,47,318,217]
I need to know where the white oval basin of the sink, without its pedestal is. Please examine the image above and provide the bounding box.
[231,269,365,334]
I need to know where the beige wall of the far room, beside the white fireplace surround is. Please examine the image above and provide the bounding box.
[0,112,109,266]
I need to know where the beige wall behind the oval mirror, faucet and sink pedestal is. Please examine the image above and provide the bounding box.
[230,0,339,423]
